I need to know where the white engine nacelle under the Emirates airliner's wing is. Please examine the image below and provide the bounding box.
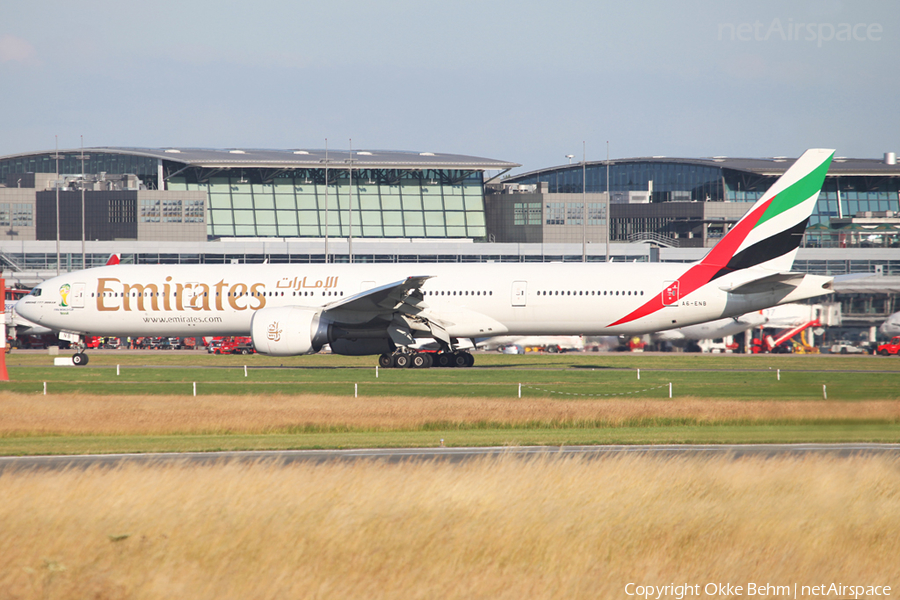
[250,306,329,356]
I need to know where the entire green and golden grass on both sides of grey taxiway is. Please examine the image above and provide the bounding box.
[0,353,900,600]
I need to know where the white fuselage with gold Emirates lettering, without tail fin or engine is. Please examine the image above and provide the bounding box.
[17,263,830,337]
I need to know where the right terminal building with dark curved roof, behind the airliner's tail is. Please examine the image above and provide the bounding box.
[488,153,900,248]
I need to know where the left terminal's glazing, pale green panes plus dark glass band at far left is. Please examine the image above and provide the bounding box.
[0,150,487,239]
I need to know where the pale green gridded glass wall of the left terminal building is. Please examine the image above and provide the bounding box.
[167,169,486,239]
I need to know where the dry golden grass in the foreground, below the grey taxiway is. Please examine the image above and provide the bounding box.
[0,457,900,600]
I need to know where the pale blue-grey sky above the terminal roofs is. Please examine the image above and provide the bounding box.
[0,0,900,173]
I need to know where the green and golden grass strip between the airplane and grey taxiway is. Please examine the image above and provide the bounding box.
[0,351,900,454]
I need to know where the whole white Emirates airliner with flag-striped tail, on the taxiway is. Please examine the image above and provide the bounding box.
[17,149,834,367]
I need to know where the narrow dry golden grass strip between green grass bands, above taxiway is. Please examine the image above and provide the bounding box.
[0,393,900,436]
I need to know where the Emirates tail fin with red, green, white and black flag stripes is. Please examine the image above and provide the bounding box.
[700,149,834,280]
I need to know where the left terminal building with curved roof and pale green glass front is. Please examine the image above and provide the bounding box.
[0,148,519,240]
